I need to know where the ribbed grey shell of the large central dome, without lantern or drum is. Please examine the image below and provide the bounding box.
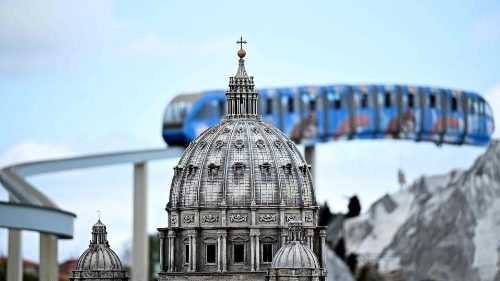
[170,118,316,207]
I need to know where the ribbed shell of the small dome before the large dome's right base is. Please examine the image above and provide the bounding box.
[271,241,319,268]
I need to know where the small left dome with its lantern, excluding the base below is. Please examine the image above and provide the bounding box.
[76,220,123,270]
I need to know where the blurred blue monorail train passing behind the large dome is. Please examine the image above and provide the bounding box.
[163,85,494,146]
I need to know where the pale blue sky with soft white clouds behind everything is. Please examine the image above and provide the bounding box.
[0,0,500,261]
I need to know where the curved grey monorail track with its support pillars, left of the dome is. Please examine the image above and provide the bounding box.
[0,147,184,281]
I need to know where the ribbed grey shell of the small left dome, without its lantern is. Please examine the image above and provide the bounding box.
[76,244,123,270]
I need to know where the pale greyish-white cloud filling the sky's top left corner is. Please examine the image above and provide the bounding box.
[0,0,115,76]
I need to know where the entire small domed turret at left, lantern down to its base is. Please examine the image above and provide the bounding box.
[69,219,128,281]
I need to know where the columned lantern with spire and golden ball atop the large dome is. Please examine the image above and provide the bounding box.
[224,37,260,120]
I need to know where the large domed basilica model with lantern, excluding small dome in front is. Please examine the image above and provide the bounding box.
[158,43,325,281]
